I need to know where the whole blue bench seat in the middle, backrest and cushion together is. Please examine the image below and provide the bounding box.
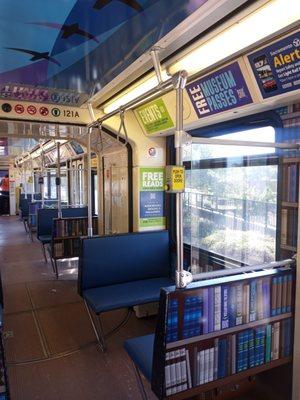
[78,231,173,348]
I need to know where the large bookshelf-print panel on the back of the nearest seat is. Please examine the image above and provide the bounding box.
[152,268,295,400]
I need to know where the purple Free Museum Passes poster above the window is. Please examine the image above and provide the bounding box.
[186,62,253,118]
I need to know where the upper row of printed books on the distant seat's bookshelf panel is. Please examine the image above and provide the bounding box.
[54,217,98,237]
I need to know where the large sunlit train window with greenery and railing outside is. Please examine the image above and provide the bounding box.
[184,126,278,272]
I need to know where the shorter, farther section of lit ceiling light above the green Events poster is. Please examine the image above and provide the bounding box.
[103,70,168,114]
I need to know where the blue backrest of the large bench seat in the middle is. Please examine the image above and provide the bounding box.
[78,231,170,293]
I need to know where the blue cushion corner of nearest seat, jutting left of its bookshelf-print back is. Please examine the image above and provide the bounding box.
[124,334,155,382]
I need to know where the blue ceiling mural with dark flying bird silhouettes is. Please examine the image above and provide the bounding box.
[0,0,207,95]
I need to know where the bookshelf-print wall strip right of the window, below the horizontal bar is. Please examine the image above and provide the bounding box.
[279,157,300,258]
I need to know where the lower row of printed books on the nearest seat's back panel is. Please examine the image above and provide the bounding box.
[165,318,292,396]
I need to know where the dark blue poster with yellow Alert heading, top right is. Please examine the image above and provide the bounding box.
[248,32,300,99]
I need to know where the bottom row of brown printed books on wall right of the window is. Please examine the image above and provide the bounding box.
[281,208,298,248]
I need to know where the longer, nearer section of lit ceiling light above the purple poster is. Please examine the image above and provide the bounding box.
[169,0,300,75]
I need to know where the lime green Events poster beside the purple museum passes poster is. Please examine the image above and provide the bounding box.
[136,99,174,133]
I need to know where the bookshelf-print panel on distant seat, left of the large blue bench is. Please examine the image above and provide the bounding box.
[51,217,98,260]
